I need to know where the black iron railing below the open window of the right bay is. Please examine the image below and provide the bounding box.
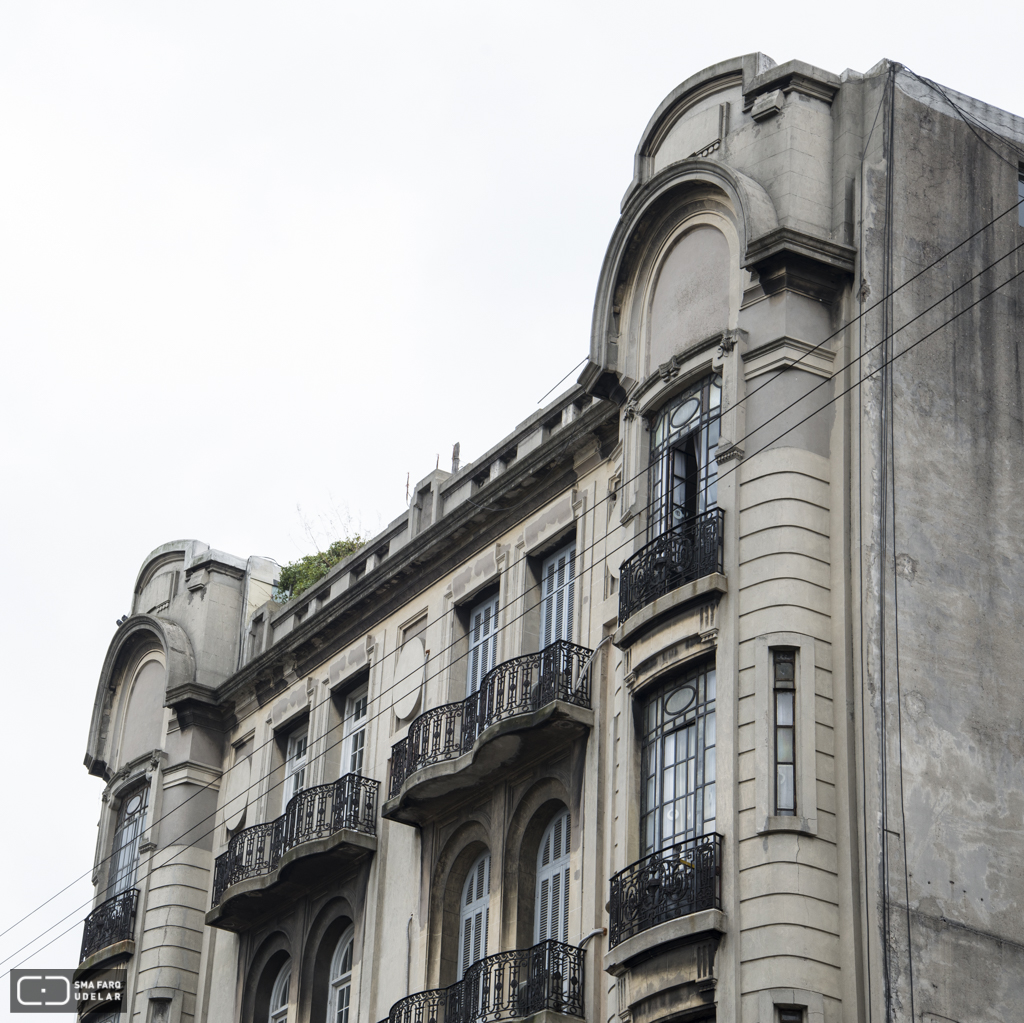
[618,508,723,623]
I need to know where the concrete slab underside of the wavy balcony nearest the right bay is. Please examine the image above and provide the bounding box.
[381,699,594,826]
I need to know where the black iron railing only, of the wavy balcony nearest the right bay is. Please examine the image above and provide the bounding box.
[388,640,593,799]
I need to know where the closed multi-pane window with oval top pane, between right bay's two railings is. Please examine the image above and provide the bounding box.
[640,663,716,856]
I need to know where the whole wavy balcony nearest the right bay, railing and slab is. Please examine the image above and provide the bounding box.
[381,640,593,824]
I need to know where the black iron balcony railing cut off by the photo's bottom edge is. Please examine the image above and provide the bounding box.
[381,938,584,1023]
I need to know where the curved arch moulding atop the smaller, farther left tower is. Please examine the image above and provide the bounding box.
[85,614,196,780]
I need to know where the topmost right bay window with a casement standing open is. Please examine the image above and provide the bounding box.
[648,376,722,540]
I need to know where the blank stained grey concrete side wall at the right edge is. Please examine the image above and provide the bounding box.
[861,73,1024,1023]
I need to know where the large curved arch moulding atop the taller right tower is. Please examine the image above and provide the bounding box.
[580,159,778,401]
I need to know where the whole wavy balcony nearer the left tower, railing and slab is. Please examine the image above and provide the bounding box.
[206,774,380,931]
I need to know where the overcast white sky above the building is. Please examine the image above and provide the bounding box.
[0,0,1024,1016]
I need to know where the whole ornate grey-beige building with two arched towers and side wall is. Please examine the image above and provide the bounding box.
[82,54,1024,1023]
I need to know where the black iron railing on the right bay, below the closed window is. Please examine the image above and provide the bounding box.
[608,835,722,948]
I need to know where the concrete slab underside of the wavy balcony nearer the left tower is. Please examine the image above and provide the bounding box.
[206,828,377,933]
